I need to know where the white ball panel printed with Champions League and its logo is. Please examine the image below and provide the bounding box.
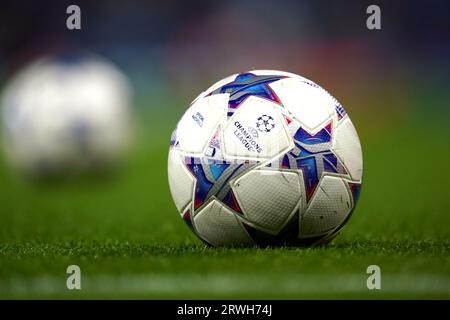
[224,96,293,161]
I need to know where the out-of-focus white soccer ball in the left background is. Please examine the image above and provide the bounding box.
[1,53,131,175]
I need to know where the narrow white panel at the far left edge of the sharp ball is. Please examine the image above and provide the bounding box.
[168,150,195,213]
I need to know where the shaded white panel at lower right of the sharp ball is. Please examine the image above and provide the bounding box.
[300,176,352,238]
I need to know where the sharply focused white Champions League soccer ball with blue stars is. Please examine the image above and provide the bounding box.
[168,70,363,246]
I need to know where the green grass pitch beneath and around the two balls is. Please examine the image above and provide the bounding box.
[0,110,450,299]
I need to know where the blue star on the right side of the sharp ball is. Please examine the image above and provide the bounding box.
[281,122,347,202]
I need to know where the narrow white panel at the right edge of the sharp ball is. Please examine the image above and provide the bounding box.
[333,118,363,181]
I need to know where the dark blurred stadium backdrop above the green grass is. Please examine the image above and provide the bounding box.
[0,0,450,135]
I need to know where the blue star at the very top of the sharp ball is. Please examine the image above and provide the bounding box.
[209,72,287,118]
